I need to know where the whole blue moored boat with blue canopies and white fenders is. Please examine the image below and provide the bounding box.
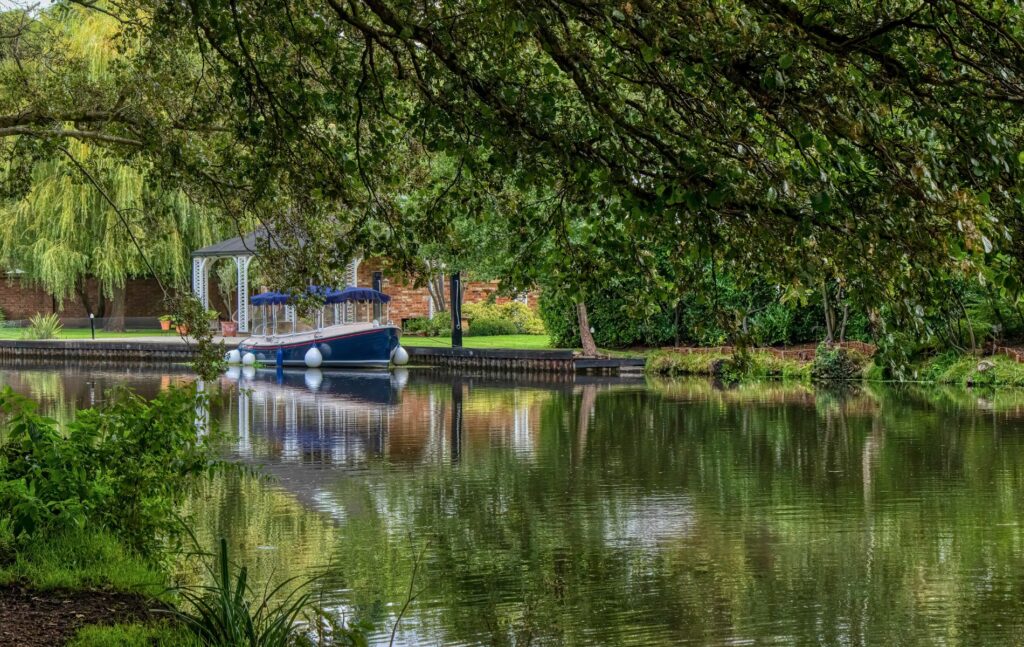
[227,288,409,369]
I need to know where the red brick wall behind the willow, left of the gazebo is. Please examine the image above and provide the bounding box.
[0,277,164,319]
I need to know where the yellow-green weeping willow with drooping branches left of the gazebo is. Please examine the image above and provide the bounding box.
[0,8,222,330]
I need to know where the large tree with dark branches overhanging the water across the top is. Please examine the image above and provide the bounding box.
[6,0,1024,348]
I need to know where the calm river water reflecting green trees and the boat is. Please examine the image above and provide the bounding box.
[0,365,1024,645]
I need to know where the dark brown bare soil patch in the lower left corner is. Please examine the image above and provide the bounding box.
[0,586,162,647]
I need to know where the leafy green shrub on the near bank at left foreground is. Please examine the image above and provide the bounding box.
[0,387,218,558]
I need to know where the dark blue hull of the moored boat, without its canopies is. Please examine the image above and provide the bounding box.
[239,326,399,368]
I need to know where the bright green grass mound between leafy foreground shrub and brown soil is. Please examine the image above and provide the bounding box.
[0,530,165,595]
